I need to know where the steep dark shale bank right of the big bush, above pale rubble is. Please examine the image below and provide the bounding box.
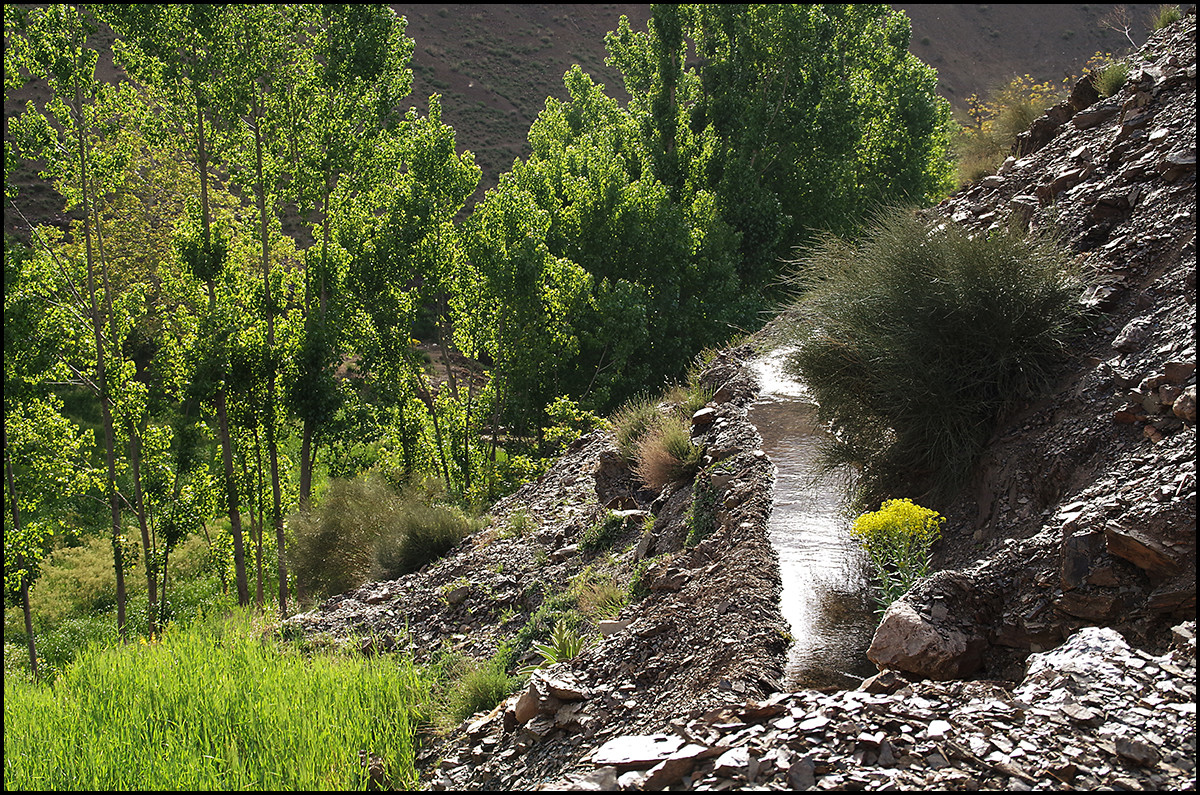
[875,6,1196,679]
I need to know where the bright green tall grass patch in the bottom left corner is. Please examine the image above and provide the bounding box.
[4,617,431,790]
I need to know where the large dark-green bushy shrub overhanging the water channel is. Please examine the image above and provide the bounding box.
[790,210,1082,504]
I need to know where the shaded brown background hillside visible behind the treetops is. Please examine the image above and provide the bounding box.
[4,4,1176,232]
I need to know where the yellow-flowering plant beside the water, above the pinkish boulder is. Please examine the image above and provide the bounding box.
[850,500,946,615]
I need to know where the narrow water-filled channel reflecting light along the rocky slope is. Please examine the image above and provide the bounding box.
[749,349,876,689]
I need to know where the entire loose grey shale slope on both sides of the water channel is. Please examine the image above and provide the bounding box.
[290,12,1196,790]
